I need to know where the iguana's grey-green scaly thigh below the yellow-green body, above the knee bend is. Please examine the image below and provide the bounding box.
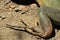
[40,6,60,25]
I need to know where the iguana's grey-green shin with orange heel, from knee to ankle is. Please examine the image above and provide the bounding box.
[38,8,53,38]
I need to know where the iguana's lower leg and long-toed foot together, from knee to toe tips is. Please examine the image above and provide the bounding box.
[7,8,53,38]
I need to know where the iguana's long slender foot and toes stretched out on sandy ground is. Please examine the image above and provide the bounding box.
[6,24,43,36]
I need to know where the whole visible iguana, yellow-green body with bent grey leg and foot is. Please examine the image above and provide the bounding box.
[4,0,60,38]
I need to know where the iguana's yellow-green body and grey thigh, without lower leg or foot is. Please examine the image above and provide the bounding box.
[36,0,60,25]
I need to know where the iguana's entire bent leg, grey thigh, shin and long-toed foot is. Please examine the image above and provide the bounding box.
[6,6,60,38]
